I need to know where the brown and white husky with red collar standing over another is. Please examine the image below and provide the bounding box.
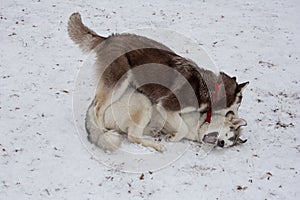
[68,13,248,145]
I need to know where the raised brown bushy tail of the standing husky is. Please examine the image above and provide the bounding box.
[68,13,106,52]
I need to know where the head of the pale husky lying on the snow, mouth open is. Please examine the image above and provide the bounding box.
[202,111,247,148]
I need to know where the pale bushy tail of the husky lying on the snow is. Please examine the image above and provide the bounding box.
[85,103,121,151]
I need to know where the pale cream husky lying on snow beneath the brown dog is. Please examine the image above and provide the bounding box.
[86,87,246,152]
